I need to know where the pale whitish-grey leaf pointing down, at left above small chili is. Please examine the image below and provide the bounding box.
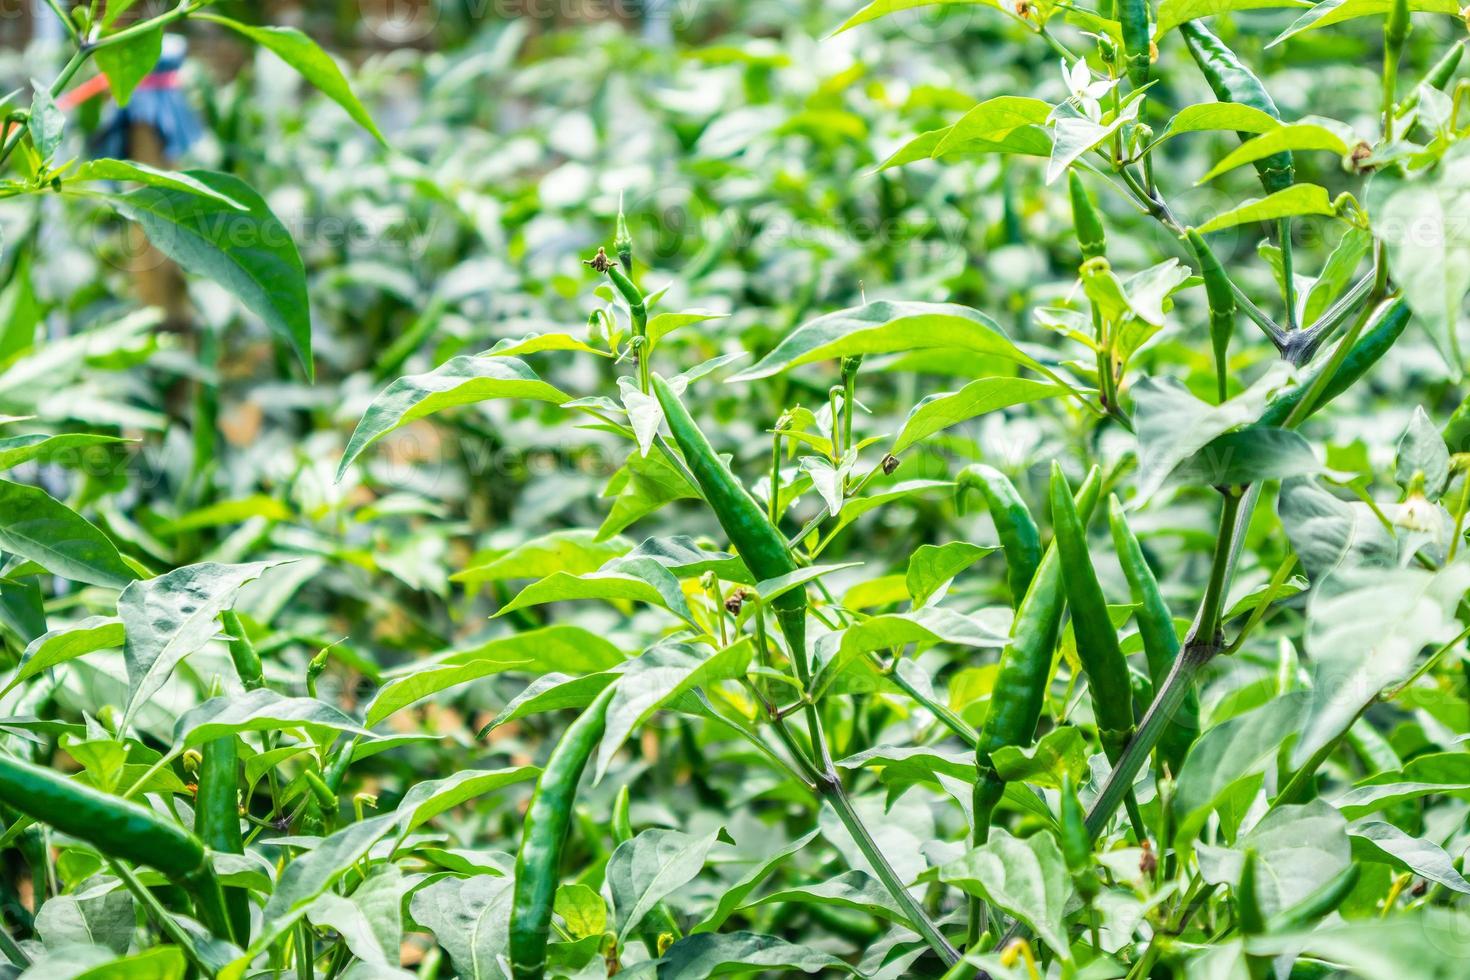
[118,561,281,730]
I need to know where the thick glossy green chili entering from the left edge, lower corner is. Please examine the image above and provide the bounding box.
[0,755,232,939]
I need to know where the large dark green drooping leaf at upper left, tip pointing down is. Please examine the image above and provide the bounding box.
[107,170,315,379]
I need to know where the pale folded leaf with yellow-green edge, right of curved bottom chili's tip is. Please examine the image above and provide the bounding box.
[595,636,756,780]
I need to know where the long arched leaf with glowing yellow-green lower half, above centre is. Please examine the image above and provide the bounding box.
[731,301,1038,382]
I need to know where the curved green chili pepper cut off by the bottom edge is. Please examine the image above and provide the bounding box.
[510,686,616,980]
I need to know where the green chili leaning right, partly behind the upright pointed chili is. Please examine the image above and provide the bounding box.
[975,467,1103,843]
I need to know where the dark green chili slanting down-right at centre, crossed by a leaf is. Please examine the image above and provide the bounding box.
[653,376,810,667]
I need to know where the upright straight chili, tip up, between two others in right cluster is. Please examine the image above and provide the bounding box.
[1051,461,1133,761]
